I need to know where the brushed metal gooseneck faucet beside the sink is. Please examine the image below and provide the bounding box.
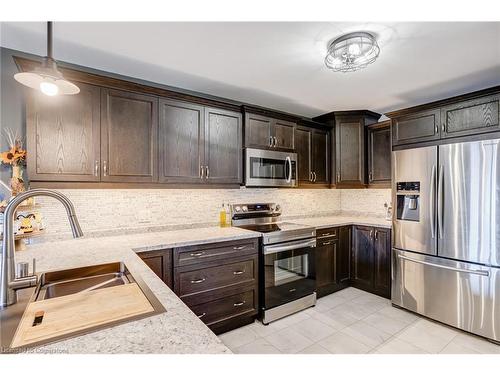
[0,189,83,309]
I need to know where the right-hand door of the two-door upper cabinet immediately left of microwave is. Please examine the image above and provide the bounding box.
[205,108,242,184]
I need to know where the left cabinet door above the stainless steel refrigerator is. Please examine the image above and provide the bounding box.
[392,109,440,146]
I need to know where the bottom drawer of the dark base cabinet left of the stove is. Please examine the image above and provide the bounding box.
[191,289,257,325]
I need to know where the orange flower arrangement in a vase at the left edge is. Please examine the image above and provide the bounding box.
[0,129,26,196]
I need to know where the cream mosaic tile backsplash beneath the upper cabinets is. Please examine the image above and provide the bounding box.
[37,188,390,239]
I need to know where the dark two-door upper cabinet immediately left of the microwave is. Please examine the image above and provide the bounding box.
[159,99,242,184]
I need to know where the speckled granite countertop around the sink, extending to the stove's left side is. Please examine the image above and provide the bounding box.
[16,227,260,354]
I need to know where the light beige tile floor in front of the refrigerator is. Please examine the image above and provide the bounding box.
[219,288,500,354]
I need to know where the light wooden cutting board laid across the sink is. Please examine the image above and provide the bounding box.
[11,283,154,348]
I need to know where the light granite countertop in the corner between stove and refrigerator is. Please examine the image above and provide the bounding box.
[284,215,392,229]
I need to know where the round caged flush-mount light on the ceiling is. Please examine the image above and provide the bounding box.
[325,32,380,73]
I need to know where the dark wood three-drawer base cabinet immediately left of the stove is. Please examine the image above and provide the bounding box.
[173,239,259,334]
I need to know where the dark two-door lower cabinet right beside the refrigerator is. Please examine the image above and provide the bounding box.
[351,225,391,298]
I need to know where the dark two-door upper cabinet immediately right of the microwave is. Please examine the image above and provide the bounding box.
[295,126,330,186]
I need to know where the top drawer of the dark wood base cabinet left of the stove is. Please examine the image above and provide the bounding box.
[174,240,257,267]
